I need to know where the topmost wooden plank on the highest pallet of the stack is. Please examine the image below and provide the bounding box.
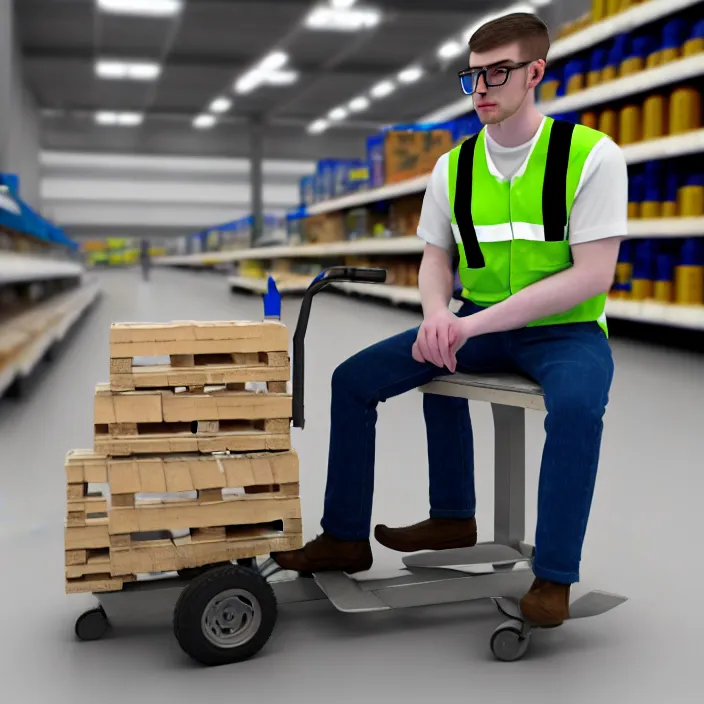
[110,321,289,358]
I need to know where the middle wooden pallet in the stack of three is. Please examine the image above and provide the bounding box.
[94,385,292,456]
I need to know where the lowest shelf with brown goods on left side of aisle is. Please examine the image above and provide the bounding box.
[0,281,101,396]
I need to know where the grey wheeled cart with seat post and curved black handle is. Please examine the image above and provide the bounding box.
[75,267,626,666]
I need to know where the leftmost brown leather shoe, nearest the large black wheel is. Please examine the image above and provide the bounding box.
[271,533,374,574]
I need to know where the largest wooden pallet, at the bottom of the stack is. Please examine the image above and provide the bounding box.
[65,451,303,593]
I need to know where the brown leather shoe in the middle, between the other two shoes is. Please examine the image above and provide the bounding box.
[374,518,477,552]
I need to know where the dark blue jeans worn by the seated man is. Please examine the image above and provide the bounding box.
[321,303,613,584]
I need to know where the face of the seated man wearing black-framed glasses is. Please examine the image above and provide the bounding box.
[469,43,535,125]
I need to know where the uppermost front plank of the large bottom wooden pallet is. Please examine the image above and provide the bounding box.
[108,450,300,494]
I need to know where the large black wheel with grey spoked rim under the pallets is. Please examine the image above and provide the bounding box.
[174,565,278,666]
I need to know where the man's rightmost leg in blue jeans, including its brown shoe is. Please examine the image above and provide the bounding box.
[512,324,614,625]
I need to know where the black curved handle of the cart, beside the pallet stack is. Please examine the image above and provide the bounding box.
[292,266,386,428]
